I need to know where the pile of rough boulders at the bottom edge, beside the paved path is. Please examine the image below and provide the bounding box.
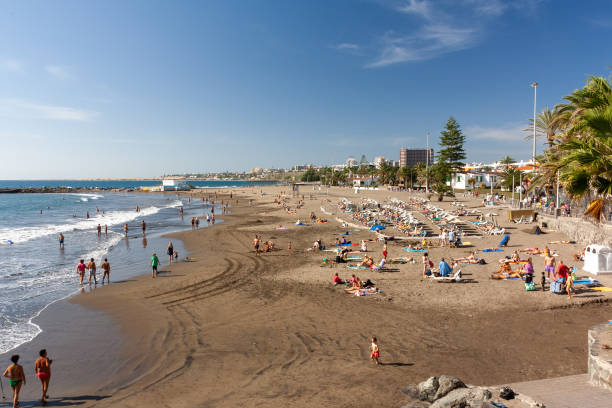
[402,375,544,408]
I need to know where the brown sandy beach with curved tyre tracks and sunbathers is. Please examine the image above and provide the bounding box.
[5,186,612,407]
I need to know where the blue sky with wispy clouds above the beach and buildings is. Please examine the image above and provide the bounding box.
[0,0,612,179]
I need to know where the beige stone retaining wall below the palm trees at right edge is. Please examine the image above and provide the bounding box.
[538,214,612,248]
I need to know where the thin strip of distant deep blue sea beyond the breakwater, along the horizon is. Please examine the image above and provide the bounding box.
[0,180,276,189]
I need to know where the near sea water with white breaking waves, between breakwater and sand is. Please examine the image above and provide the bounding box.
[0,192,221,354]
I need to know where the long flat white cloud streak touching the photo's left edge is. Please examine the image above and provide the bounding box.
[0,99,99,122]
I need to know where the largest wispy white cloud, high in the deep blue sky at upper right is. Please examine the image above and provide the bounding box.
[366,24,478,68]
